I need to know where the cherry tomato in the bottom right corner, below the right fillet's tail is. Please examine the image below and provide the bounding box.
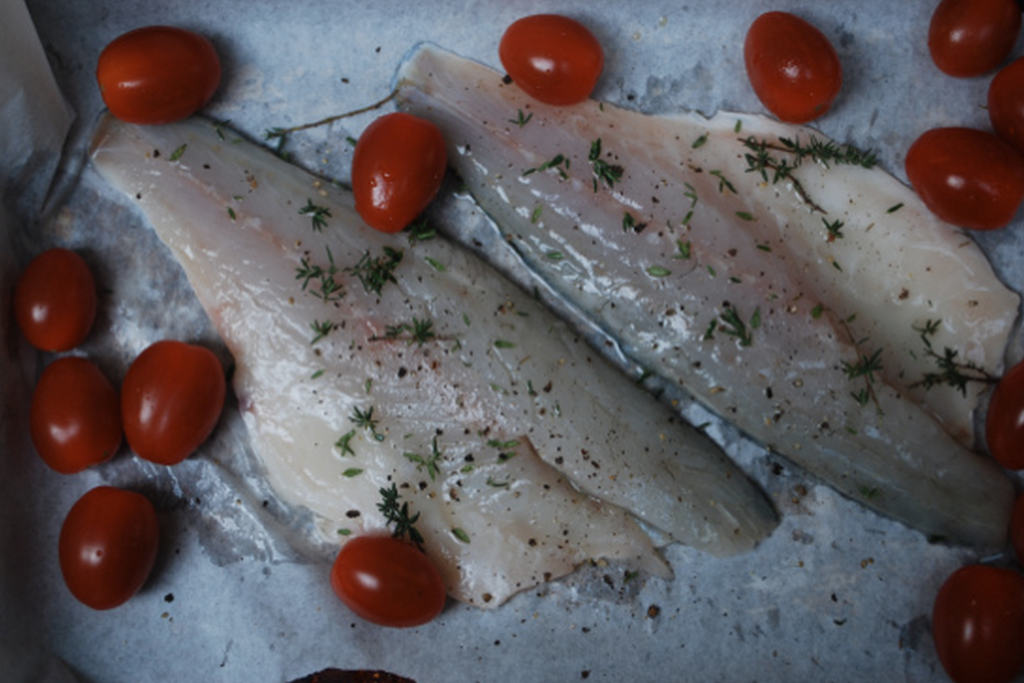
[932,564,1024,683]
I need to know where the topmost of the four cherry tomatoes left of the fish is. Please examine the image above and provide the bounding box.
[14,249,96,351]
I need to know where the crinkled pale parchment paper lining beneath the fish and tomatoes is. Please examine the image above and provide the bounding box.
[6,0,1024,683]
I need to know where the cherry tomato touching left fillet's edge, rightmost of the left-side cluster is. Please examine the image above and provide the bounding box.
[121,340,226,465]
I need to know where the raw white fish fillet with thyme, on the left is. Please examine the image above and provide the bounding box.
[92,114,776,606]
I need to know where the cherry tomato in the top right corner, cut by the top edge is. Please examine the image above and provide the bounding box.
[928,0,1021,78]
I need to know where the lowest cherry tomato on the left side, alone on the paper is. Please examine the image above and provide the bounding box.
[58,486,160,609]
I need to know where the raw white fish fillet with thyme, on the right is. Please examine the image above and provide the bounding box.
[398,46,1018,545]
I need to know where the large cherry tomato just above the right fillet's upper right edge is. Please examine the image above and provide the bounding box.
[905,128,1024,230]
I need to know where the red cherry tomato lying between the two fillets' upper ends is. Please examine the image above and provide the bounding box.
[352,112,447,232]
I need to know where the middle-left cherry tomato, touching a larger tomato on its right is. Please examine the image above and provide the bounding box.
[29,356,123,474]
